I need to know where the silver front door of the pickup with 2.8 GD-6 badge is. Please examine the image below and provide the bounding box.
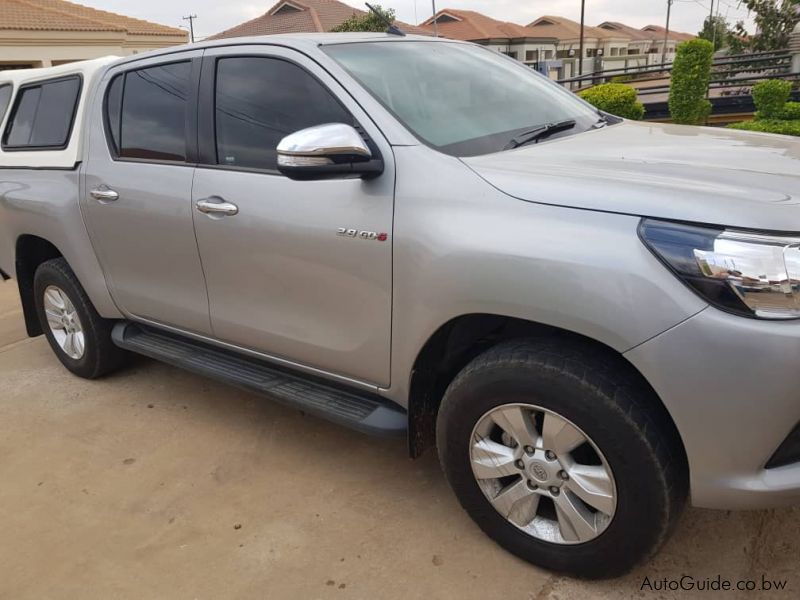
[192,46,394,385]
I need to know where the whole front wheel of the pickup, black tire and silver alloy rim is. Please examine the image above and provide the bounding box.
[437,341,688,578]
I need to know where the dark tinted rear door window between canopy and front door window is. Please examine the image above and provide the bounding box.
[118,62,191,161]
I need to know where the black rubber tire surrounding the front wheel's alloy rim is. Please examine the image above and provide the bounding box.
[437,340,688,579]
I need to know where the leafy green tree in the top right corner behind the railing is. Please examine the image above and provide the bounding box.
[734,0,800,52]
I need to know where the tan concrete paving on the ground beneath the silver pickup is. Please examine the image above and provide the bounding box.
[0,282,800,600]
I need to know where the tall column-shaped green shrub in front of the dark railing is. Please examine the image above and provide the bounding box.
[669,39,714,125]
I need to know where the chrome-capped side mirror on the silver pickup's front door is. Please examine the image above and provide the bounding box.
[277,123,383,181]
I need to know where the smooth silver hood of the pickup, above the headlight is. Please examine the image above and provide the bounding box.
[463,121,800,232]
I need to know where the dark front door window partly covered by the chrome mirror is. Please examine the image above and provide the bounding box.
[215,57,354,170]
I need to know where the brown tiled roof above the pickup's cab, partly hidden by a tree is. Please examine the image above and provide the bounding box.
[209,0,427,40]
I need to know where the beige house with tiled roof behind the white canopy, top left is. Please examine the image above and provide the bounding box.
[0,0,188,70]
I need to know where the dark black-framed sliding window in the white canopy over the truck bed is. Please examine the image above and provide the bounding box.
[3,76,81,150]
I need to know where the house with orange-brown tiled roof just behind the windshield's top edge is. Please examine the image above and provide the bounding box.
[421,8,560,76]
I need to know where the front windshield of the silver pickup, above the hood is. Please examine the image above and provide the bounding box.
[323,41,599,156]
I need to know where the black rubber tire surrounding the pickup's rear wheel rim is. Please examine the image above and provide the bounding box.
[33,258,127,379]
